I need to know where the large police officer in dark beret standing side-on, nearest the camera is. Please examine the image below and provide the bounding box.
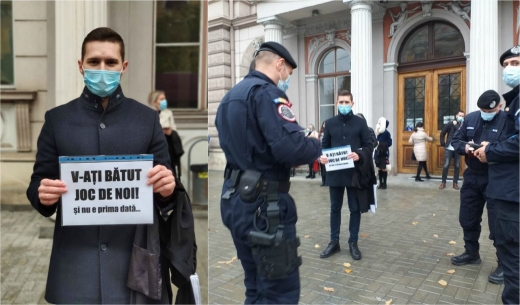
[215,42,321,304]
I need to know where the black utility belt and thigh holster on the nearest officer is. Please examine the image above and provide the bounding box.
[222,166,302,280]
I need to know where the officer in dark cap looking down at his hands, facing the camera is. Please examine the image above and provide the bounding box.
[451,90,506,284]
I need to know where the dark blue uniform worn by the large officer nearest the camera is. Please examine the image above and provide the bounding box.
[215,71,321,304]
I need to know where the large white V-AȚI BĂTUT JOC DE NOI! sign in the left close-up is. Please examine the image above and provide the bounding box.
[59,155,154,226]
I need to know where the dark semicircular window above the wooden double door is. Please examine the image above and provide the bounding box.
[398,21,466,72]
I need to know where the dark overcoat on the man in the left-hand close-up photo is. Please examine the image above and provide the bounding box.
[27,87,173,304]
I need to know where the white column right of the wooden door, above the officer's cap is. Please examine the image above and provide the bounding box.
[466,0,499,112]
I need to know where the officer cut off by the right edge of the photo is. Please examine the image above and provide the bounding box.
[475,46,520,304]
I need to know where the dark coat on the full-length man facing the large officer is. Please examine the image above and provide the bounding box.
[322,112,372,186]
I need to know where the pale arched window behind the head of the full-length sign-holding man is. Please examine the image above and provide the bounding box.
[318,47,350,125]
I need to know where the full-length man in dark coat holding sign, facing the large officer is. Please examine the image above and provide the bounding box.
[319,90,373,260]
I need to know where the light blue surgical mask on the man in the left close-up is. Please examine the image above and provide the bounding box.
[83,68,123,97]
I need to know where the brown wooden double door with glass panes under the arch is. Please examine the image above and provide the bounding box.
[397,66,466,176]
